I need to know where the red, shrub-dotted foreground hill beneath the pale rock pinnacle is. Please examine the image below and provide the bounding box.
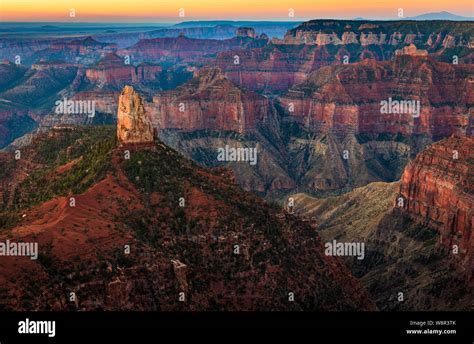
[0,119,373,311]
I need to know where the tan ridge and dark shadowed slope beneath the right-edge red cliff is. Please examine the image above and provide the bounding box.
[292,180,474,311]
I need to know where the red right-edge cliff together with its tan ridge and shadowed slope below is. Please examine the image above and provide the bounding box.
[293,137,474,310]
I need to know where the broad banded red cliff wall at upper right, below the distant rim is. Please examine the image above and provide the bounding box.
[280,55,474,138]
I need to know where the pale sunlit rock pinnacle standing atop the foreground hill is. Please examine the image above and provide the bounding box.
[117,86,153,143]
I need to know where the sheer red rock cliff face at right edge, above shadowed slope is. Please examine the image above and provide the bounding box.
[399,136,474,259]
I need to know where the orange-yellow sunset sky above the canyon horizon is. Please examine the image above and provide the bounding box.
[0,0,474,22]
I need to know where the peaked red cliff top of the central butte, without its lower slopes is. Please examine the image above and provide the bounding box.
[150,68,270,133]
